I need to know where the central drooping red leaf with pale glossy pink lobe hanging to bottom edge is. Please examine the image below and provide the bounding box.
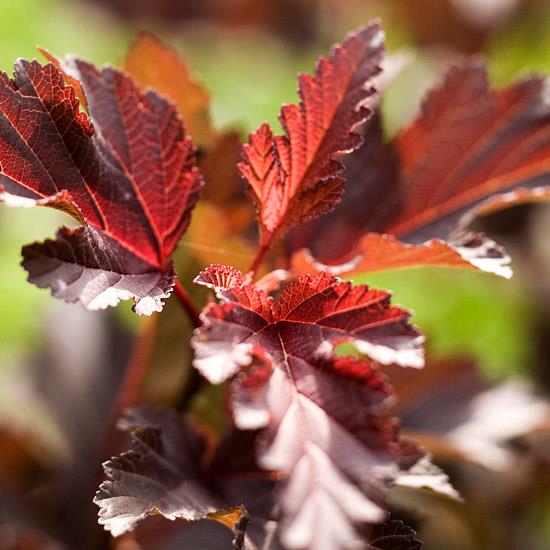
[193,266,422,549]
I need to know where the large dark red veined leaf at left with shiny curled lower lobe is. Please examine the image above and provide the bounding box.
[0,59,202,313]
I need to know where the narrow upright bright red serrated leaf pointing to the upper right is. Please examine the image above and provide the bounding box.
[239,23,383,251]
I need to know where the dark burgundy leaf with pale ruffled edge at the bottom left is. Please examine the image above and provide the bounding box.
[94,410,216,536]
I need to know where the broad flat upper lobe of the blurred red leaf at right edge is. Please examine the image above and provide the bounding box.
[384,61,550,242]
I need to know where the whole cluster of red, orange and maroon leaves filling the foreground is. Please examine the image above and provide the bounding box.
[0,21,550,550]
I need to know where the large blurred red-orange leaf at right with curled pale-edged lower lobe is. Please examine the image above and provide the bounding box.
[295,60,550,277]
